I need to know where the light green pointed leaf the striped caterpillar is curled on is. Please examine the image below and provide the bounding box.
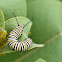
[0,16,44,54]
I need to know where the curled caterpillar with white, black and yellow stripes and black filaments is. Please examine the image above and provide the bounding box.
[8,13,32,52]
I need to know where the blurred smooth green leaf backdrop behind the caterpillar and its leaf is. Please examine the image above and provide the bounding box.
[0,0,62,62]
